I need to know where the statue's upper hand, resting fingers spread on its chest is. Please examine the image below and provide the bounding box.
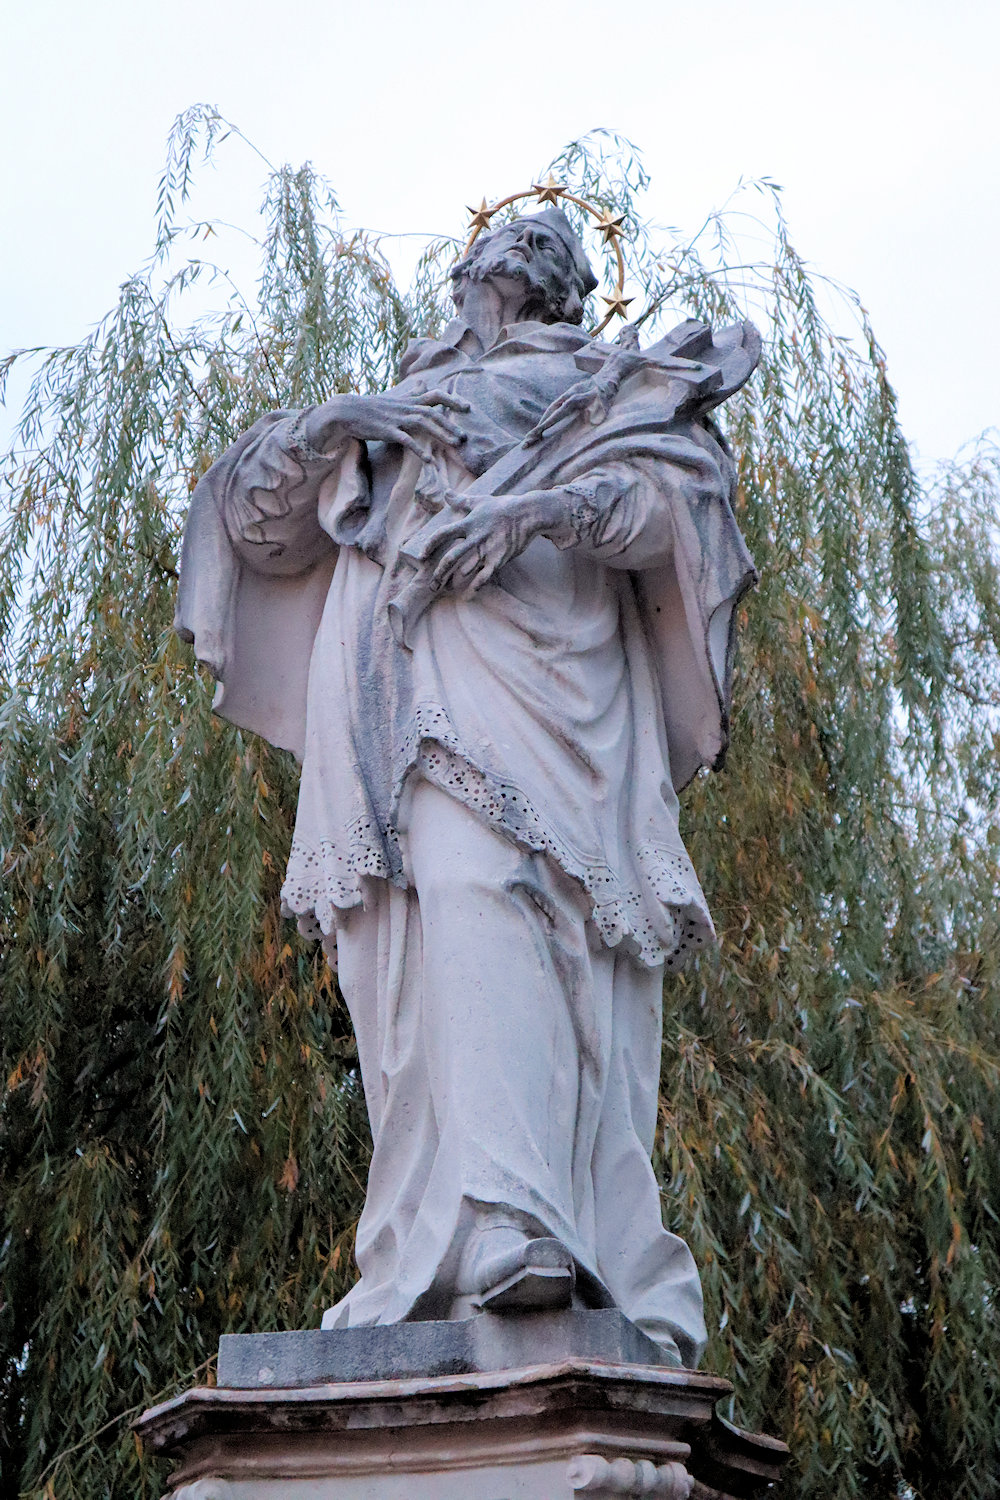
[303,390,469,461]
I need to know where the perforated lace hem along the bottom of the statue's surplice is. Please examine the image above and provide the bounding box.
[282,705,715,971]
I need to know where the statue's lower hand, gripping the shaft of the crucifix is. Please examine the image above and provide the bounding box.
[405,489,561,597]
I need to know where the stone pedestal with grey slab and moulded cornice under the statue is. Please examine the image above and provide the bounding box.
[136,1313,787,1500]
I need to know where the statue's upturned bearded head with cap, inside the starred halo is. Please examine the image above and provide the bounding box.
[451,209,597,323]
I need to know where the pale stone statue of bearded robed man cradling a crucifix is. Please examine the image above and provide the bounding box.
[177,207,759,1365]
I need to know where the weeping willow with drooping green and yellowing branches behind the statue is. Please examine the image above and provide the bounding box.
[0,110,1000,1500]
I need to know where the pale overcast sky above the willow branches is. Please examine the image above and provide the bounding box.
[0,0,1000,459]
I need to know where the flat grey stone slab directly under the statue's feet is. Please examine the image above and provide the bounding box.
[219,1310,667,1389]
